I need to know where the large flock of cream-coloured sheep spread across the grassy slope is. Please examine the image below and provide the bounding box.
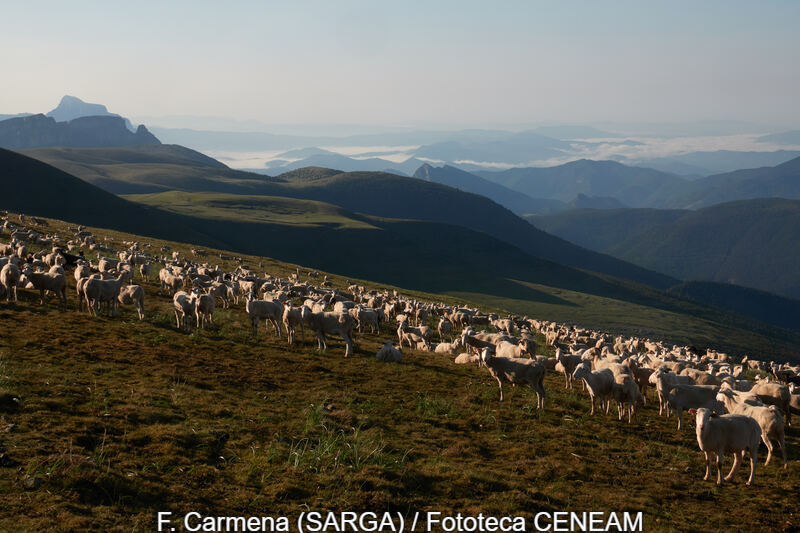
[0,209,800,485]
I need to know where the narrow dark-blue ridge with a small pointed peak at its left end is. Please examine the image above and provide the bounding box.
[414,163,564,214]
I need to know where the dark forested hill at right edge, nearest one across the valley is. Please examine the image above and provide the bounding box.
[530,198,800,298]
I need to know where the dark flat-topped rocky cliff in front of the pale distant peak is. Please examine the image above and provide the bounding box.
[0,114,160,150]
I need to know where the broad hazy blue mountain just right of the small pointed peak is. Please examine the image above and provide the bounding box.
[475,159,687,207]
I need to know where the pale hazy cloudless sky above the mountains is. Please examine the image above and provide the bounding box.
[0,0,800,126]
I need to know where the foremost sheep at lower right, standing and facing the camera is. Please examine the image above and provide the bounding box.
[690,407,761,486]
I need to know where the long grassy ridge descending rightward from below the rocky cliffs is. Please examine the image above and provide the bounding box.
[20,146,676,288]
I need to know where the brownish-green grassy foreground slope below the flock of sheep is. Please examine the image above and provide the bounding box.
[0,214,800,533]
